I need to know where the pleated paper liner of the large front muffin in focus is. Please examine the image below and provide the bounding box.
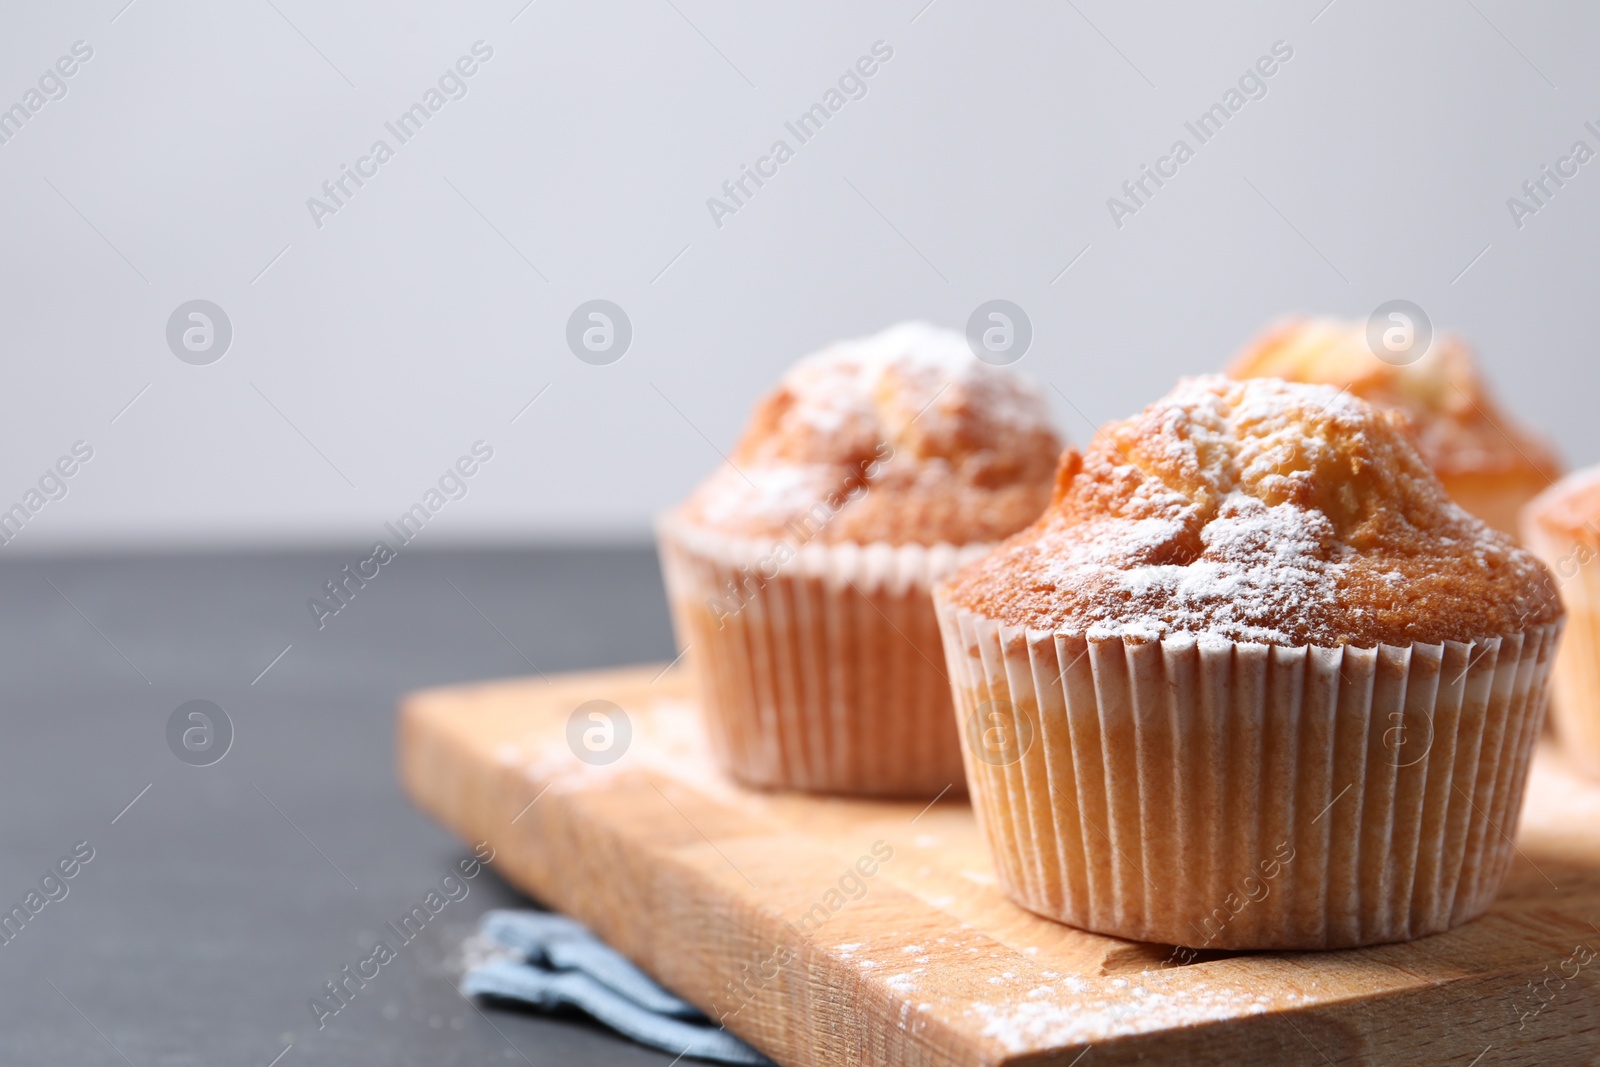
[939,603,1562,950]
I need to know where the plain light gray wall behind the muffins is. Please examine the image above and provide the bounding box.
[0,0,1600,552]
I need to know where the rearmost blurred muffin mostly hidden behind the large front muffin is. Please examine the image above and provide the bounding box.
[1227,318,1562,536]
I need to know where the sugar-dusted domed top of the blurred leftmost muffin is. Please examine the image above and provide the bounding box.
[678,323,1061,545]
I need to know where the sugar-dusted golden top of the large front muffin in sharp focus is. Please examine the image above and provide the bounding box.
[944,376,1560,648]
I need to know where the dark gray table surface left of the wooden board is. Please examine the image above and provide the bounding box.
[0,547,674,1067]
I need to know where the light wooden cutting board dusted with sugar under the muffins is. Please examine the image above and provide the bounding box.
[398,665,1600,1067]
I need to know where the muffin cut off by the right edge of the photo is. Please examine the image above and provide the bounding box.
[1522,467,1600,776]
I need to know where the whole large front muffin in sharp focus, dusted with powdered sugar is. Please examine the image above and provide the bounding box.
[934,376,1562,949]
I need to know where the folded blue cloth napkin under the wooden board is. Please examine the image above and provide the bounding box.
[461,910,773,1065]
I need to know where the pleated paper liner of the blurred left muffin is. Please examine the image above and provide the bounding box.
[658,517,989,797]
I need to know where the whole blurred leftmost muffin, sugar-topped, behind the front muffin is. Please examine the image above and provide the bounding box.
[658,323,1061,797]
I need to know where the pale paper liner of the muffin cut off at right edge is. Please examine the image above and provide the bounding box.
[1523,520,1600,776]
